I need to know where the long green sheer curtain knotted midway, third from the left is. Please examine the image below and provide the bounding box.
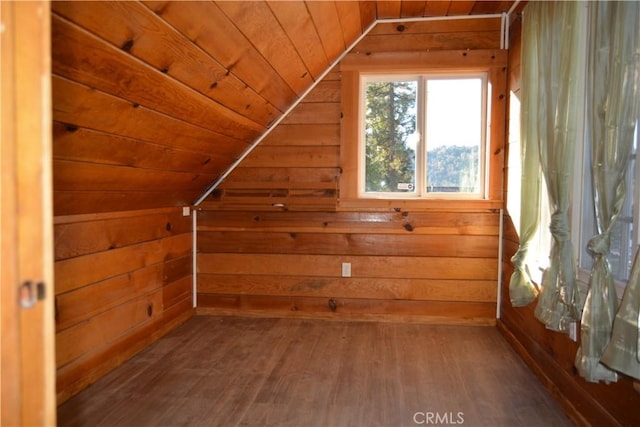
[575,1,640,382]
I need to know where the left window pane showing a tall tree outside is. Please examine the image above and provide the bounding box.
[365,80,418,193]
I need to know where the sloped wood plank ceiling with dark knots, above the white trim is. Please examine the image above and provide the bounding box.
[51,1,516,215]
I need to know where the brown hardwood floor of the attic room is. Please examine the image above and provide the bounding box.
[58,316,572,427]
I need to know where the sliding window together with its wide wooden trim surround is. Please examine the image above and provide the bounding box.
[338,49,507,210]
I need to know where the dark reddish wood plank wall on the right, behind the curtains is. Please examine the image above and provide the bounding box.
[498,17,640,426]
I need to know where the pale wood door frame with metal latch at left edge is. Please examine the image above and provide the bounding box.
[0,1,56,426]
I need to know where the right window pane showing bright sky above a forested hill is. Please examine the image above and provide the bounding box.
[426,78,483,193]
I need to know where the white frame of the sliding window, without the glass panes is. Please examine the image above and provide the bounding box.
[357,70,491,200]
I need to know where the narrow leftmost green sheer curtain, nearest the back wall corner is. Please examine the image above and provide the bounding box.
[509,5,541,307]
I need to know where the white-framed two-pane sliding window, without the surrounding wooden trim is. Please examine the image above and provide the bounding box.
[358,73,487,198]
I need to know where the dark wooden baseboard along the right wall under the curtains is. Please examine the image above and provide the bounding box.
[496,319,620,426]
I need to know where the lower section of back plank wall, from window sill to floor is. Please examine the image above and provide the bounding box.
[197,210,499,324]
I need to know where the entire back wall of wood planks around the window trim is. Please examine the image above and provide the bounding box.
[197,16,499,324]
